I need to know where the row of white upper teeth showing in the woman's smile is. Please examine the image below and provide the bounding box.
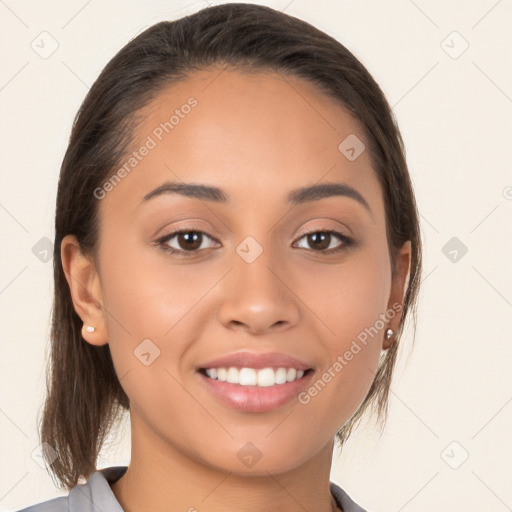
[205,367,304,387]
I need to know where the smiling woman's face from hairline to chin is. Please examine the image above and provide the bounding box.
[81,70,408,474]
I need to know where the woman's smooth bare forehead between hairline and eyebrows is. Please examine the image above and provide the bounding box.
[102,69,380,216]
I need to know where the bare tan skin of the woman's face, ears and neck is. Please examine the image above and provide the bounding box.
[61,70,410,512]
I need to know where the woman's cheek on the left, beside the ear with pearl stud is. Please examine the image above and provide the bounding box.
[96,244,204,424]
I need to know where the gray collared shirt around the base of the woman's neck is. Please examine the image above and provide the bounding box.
[18,466,365,512]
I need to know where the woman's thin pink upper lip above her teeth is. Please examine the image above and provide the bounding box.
[199,352,311,371]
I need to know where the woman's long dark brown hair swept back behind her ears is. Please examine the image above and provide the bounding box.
[39,3,421,489]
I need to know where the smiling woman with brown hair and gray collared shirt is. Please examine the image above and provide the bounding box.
[18,4,421,512]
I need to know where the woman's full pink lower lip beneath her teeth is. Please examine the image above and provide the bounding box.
[198,371,313,412]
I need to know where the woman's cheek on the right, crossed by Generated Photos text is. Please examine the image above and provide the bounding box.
[302,251,391,412]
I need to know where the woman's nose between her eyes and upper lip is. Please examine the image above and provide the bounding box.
[218,244,300,335]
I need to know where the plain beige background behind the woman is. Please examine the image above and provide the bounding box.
[0,0,512,512]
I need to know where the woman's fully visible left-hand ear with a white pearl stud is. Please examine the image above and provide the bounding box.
[60,235,108,346]
